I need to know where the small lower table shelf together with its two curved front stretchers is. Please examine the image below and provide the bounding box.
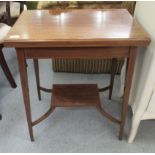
[32,84,121,126]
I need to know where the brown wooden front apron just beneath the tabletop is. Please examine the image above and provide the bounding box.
[22,47,130,59]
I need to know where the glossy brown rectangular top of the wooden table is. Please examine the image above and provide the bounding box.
[4,9,150,47]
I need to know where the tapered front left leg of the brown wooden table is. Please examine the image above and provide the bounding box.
[16,49,34,141]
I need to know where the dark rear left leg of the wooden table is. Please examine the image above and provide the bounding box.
[33,59,41,100]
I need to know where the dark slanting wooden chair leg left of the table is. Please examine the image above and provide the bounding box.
[0,46,17,88]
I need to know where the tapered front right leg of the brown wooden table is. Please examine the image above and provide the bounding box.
[119,47,137,140]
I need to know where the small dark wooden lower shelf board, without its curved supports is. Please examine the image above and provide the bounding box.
[51,84,100,107]
